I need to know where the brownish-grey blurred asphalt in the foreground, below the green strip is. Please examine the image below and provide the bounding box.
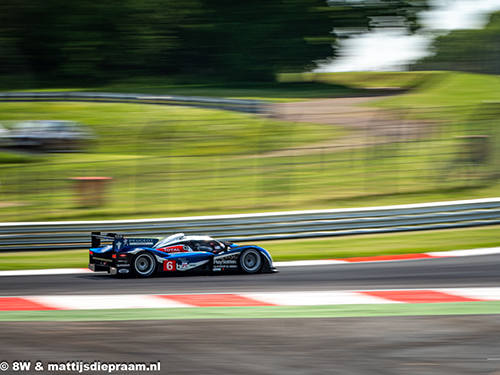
[0,315,500,375]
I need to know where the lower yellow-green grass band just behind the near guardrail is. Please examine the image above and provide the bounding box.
[0,140,498,221]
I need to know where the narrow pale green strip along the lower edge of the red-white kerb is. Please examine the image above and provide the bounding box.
[0,301,500,322]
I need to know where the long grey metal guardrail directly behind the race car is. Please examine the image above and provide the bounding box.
[0,198,500,251]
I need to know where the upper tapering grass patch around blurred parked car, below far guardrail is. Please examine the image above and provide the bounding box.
[0,102,343,156]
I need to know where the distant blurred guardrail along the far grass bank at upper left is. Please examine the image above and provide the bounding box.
[0,91,267,113]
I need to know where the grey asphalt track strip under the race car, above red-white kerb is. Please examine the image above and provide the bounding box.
[0,255,500,296]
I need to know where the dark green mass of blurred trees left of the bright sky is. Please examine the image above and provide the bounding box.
[0,0,425,83]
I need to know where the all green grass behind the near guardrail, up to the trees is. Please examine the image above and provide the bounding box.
[0,72,500,222]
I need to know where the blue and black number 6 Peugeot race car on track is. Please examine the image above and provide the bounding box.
[89,232,277,277]
